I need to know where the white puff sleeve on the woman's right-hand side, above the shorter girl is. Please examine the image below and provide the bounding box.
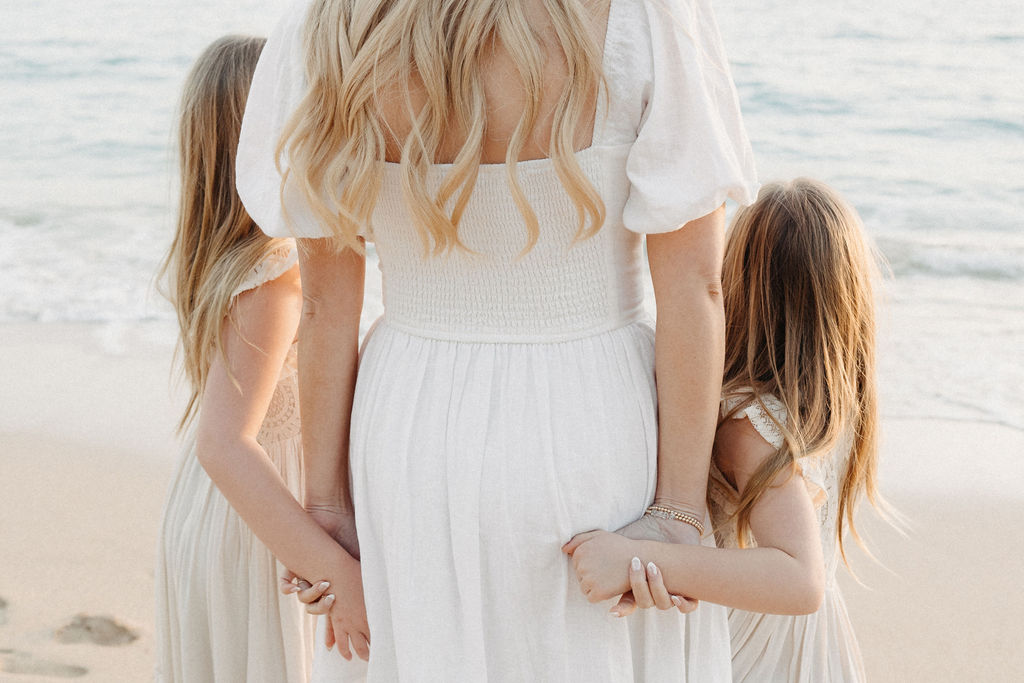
[623,0,758,232]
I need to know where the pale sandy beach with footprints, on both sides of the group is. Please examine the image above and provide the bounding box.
[0,324,1024,683]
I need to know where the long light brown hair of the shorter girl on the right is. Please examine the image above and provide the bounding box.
[723,178,886,561]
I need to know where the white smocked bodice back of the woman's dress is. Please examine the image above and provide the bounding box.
[373,146,643,342]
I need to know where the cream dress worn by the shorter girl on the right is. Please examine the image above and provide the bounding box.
[711,395,866,683]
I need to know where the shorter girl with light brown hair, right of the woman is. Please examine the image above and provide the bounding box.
[565,178,885,683]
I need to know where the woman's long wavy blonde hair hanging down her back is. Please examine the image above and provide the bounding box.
[278,0,604,254]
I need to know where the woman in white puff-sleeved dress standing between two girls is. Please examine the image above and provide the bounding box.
[239,0,756,681]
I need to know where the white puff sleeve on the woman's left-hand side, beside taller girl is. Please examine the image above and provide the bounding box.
[236,0,328,238]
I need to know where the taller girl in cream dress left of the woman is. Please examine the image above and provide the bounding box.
[155,36,366,683]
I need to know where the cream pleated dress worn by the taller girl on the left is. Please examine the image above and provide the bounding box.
[156,245,312,683]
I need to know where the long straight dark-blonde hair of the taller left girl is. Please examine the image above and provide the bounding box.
[158,36,292,430]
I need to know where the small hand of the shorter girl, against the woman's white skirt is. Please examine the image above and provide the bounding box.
[562,531,636,602]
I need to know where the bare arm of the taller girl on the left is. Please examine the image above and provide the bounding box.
[196,268,369,654]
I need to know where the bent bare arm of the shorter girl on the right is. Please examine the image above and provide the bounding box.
[566,419,824,614]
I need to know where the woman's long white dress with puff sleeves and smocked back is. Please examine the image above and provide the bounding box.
[238,0,757,683]
